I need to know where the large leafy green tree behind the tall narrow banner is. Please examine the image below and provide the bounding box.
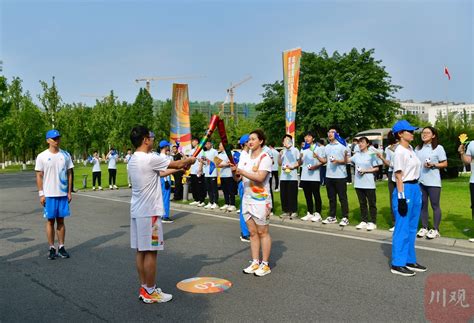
[257,49,400,139]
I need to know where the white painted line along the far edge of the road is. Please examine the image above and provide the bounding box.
[75,193,474,257]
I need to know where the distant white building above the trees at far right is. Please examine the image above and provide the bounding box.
[396,100,474,125]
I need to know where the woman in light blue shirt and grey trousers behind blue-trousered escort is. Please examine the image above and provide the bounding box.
[415,127,448,239]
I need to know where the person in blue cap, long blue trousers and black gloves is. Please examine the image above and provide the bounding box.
[391,120,427,277]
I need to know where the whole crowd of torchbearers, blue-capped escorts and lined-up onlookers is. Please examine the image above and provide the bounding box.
[35,120,474,303]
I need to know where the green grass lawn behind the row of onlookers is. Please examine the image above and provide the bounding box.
[0,163,474,239]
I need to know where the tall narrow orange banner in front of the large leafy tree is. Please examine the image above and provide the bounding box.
[283,48,301,140]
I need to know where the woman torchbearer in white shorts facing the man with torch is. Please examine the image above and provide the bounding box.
[231,130,272,276]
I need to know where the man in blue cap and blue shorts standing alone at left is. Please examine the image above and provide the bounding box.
[35,129,74,260]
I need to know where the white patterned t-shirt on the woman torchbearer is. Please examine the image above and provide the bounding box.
[238,152,272,204]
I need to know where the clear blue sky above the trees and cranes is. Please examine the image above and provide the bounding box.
[0,0,474,104]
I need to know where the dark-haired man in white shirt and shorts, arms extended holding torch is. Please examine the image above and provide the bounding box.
[128,126,195,304]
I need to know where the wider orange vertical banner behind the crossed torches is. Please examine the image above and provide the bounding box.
[170,83,191,155]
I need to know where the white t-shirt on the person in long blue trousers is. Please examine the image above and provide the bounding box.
[392,145,421,182]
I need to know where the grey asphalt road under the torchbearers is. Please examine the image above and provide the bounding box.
[0,172,474,322]
